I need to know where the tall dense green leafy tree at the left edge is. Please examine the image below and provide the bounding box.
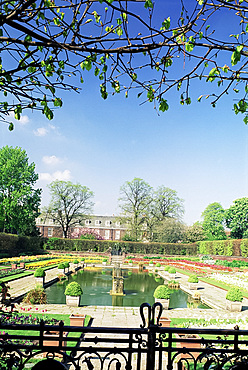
[0,146,41,235]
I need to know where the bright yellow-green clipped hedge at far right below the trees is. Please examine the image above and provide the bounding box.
[197,239,244,257]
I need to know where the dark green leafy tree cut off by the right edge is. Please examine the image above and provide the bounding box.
[225,198,248,239]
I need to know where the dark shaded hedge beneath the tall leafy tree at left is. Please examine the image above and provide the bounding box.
[0,233,45,258]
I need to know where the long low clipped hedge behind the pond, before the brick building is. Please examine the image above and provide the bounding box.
[44,238,197,256]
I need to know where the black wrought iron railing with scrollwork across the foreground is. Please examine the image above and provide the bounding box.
[0,303,248,370]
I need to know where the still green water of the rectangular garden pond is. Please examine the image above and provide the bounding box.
[46,269,208,308]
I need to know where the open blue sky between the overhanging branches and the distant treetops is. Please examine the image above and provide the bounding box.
[0,1,248,225]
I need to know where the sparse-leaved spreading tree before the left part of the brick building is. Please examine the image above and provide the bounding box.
[47,180,94,238]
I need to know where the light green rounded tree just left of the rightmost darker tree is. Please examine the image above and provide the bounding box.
[202,202,226,240]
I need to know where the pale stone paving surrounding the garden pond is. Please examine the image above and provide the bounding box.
[6,268,248,327]
